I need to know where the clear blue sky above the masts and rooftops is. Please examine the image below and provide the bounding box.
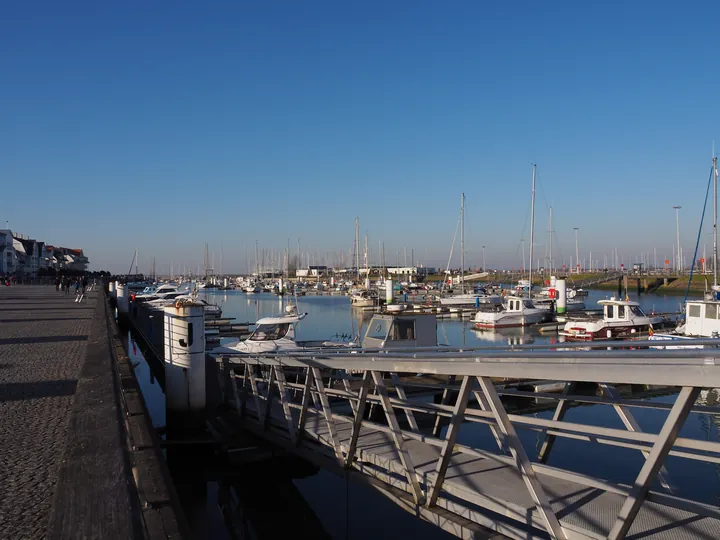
[0,0,720,272]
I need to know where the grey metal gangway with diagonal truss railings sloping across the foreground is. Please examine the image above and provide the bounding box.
[217,340,720,540]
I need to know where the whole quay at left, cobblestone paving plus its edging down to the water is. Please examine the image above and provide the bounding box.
[0,285,187,540]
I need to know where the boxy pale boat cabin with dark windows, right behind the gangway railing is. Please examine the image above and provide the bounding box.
[362,313,437,349]
